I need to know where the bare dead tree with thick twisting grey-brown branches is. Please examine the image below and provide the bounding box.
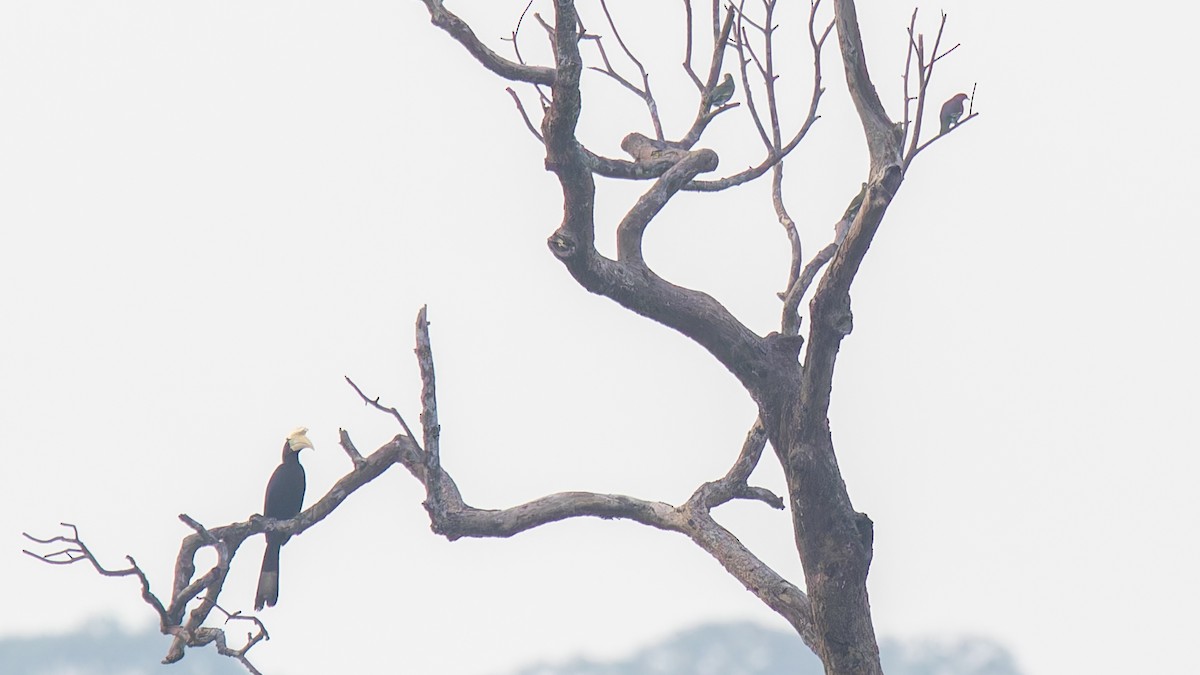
[25,0,977,675]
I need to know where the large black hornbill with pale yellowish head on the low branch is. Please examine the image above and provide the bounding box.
[254,426,312,611]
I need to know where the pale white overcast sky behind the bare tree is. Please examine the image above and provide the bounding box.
[0,0,1200,675]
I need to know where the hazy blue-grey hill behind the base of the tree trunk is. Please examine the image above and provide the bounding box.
[511,623,1021,675]
